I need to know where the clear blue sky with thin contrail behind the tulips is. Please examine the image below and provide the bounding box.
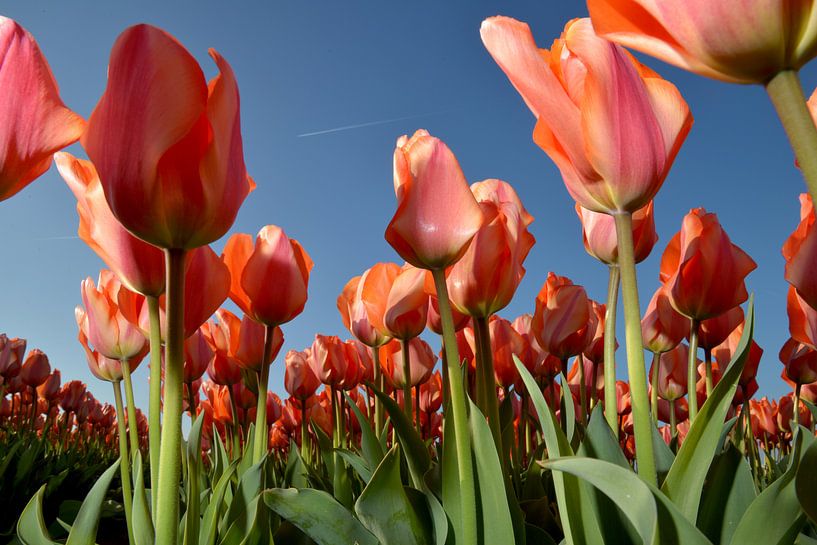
[0,0,817,406]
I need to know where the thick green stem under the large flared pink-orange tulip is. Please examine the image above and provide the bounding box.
[614,212,658,485]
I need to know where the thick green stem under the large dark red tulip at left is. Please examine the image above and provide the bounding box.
[156,249,185,545]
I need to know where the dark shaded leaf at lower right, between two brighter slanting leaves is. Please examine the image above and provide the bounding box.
[697,444,757,543]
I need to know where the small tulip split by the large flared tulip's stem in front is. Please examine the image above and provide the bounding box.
[576,201,658,265]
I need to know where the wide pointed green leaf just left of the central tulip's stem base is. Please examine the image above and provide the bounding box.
[355,446,431,545]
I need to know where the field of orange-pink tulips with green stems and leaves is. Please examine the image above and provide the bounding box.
[7,0,817,545]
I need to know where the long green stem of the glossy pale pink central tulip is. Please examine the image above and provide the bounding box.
[431,269,477,545]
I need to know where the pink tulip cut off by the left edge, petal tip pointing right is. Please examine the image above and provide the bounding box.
[0,16,85,201]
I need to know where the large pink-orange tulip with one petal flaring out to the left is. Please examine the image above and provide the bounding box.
[480,17,692,213]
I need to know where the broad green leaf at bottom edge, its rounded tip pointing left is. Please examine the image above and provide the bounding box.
[263,488,378,545]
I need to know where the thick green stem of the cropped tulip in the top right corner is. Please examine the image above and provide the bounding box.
[766,70,817,202]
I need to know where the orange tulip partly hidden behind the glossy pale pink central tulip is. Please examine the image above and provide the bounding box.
[446,179,536,318]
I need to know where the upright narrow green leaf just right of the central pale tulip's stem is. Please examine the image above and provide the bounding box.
[468,398,515,543]
